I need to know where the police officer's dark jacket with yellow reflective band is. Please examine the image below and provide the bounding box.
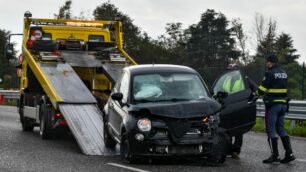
[256,65,288,105]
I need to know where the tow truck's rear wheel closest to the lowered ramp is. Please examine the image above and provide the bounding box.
[39,103,53,139]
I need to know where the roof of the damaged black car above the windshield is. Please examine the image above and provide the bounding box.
[124,64,197,75]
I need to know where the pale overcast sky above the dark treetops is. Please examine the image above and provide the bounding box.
[0,0,306,62]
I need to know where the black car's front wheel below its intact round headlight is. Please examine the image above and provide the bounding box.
[120,133,137,164]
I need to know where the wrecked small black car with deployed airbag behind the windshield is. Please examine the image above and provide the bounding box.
[103,65,254,163]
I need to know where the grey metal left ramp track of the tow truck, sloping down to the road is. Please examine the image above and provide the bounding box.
[38,59,121,155]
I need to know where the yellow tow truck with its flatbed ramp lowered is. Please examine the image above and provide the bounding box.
[6,12,136,155]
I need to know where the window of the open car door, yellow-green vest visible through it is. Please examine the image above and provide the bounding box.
[214,70,246,94]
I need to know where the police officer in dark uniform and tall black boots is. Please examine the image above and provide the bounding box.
[256,54,295,163]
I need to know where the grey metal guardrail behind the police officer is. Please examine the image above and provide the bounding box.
[256,99,306,128]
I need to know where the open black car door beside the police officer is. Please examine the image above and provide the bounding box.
[212,69,256,136]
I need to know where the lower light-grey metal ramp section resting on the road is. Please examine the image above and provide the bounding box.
[58,103,119,155]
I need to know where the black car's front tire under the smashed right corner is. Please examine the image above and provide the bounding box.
[208,129,230,164]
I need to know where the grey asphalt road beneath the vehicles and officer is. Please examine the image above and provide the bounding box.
[0,106,306,172]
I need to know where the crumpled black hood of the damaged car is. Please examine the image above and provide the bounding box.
[129,98,221,118]
